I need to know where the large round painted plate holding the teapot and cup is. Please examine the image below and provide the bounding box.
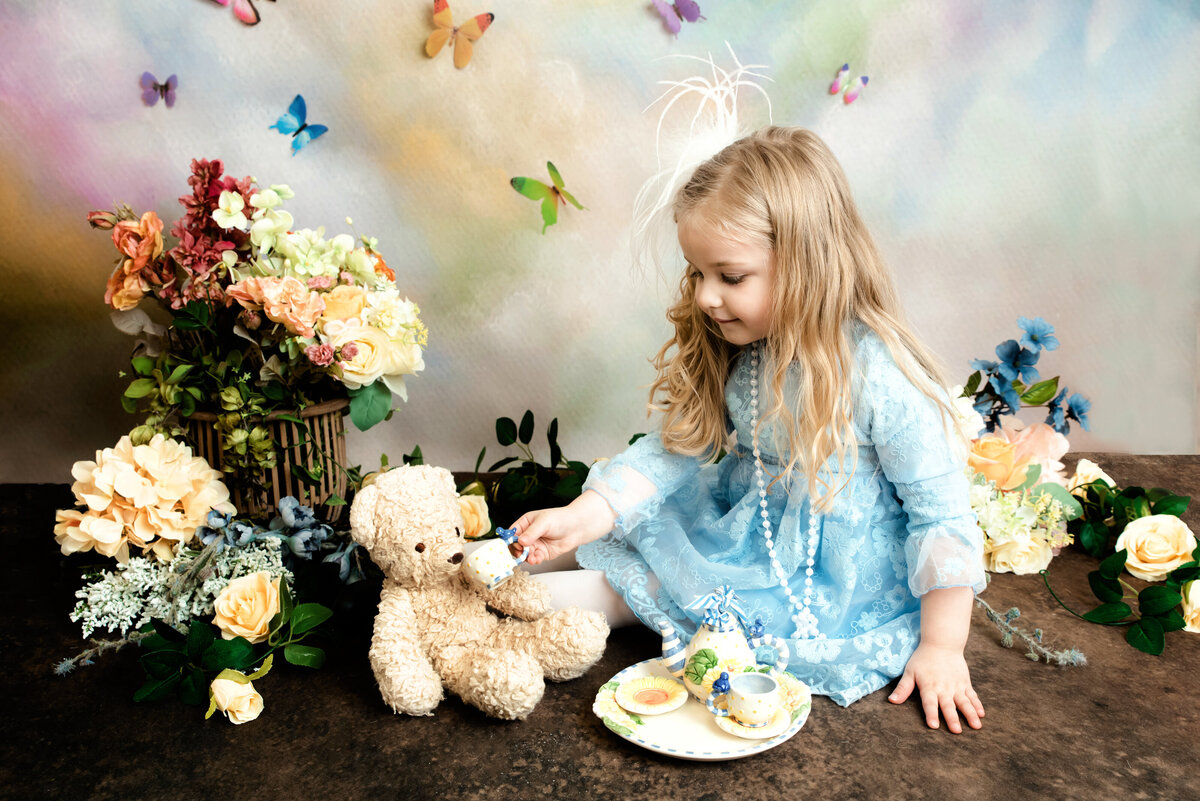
[592,658,812,761]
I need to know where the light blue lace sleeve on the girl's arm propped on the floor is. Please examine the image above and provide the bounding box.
[858,333,986,597]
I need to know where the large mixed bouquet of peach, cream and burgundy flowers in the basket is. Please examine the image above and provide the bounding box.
[88,159,426,502]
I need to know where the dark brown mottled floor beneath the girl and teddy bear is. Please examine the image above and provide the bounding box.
[0,453,1200,801]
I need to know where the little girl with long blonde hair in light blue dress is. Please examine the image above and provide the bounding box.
[515,127,984,733]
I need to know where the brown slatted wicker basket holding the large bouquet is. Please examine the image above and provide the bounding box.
[187,398,350,522]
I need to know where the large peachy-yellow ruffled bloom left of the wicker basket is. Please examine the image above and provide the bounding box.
[54,434,236,562]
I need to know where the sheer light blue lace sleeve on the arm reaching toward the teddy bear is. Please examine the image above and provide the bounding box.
[583,432,701,534]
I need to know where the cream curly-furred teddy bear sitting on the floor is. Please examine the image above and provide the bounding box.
[350,465,608,719]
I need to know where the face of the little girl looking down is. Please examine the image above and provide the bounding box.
[678,213,775,345]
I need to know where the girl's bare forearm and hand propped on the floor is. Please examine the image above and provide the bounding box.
[888,586,984,734]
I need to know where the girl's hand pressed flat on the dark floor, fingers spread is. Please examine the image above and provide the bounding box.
[888,643,984,734]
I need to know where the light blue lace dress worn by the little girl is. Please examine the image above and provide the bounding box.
[576,325,985,706]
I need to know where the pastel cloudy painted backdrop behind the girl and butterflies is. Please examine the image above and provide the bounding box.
[0,0,1200,482]
